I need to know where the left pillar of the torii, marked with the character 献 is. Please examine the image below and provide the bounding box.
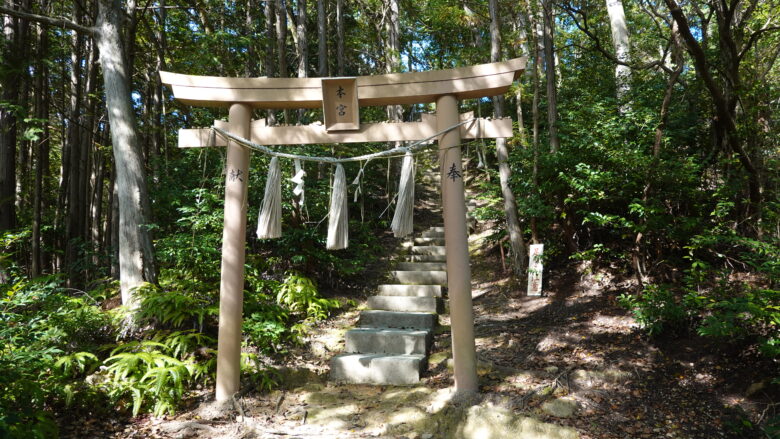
[217,104,252,401]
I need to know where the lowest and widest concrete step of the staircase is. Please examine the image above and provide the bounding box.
[330,354,427,386]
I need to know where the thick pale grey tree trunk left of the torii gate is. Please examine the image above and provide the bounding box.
[96,0,157,309]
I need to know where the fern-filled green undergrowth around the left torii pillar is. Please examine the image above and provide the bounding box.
[0,218,360,438]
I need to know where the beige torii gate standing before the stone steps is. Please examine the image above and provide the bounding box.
[160,58,526,401]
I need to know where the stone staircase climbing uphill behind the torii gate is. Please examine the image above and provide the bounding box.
[330,227,447,385]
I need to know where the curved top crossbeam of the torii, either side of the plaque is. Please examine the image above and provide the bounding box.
[160,58,526,109]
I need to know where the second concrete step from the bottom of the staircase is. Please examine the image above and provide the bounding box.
[344,328,433,355]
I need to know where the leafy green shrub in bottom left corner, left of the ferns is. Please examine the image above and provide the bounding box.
[0,276,113,438]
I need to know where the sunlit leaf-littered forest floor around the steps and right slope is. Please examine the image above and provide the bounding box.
[63,200,780,439]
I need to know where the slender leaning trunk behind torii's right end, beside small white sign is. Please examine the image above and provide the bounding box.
[488,0,526,279]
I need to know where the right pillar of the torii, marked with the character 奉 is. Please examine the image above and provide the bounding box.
[436,95,479,395]
